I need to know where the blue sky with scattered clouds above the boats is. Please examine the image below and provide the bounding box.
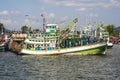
[0,0,120,30]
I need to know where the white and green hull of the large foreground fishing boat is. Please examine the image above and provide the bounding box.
[20,43,107,55]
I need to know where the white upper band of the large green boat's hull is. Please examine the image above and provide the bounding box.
[20,43,106,55]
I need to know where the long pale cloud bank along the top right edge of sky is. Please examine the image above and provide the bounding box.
[44,0,120,11]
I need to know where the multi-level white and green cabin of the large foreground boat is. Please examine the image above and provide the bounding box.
[25,24,58,50]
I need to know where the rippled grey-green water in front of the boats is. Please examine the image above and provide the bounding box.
[0,45,120,80]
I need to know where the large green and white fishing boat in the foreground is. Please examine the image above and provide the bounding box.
[19,18,106,55]
